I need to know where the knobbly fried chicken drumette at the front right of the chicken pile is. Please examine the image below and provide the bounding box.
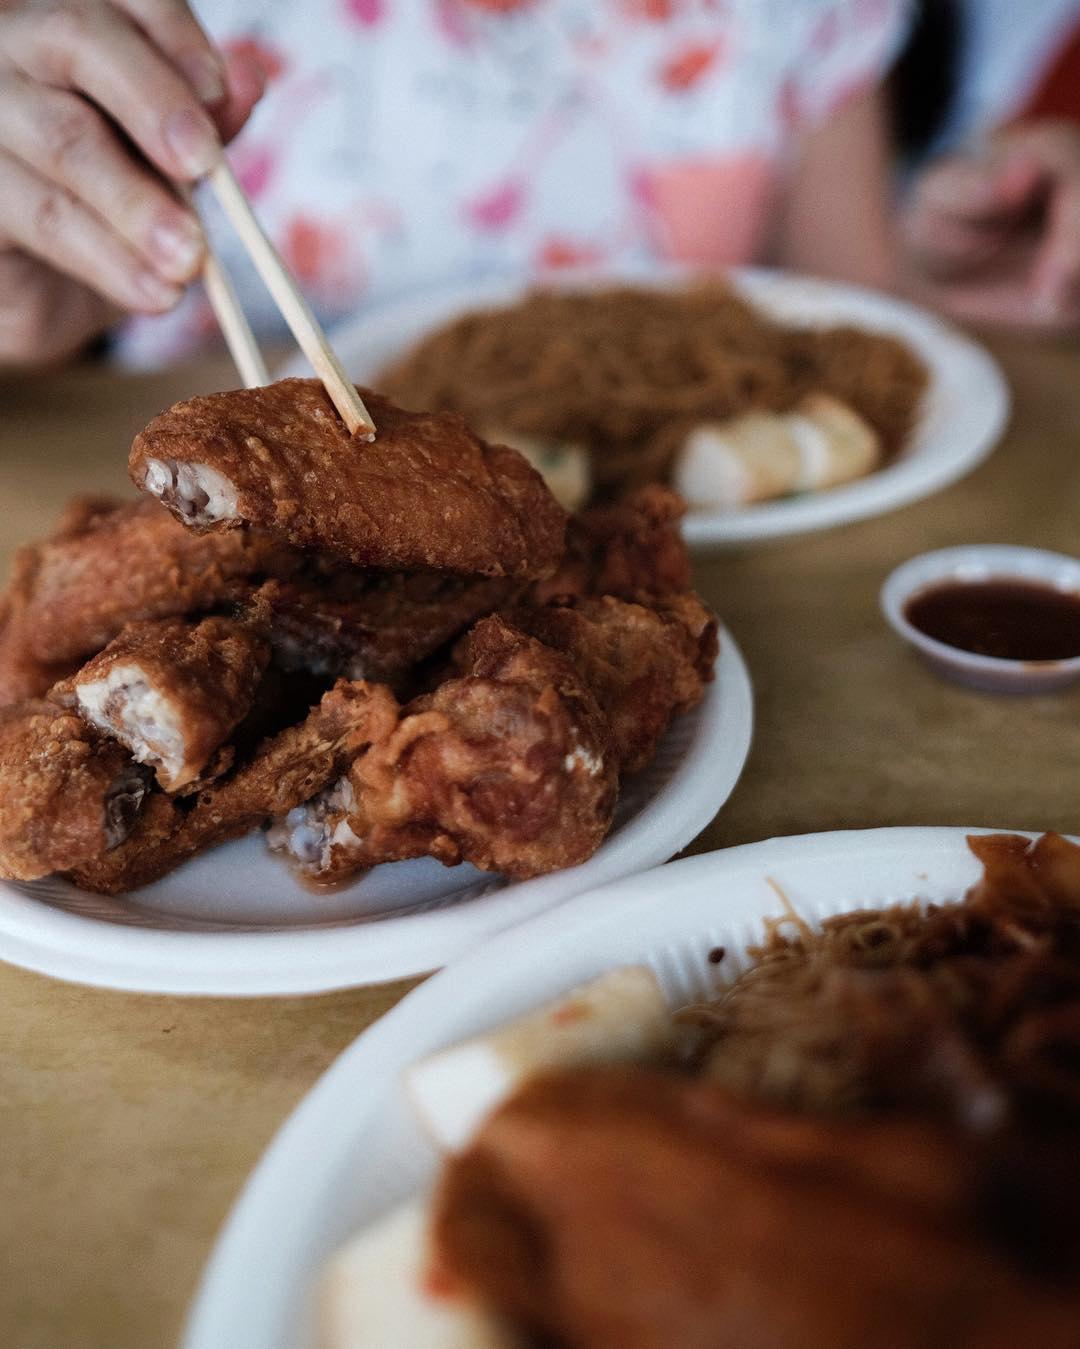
[268,615,618,882]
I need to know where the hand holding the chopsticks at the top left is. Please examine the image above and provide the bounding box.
[0,0,262,364]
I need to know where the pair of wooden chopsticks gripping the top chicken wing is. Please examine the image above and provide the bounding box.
[185,155,375,440]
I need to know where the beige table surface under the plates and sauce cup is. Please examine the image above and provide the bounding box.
[0,341,1080,1349]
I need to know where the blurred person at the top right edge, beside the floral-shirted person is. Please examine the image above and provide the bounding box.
[894,0,1080,333]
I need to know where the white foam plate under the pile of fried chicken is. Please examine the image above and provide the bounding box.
[0,630,754,997]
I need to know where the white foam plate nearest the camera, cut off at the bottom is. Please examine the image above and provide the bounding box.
[183,828,1035,1349]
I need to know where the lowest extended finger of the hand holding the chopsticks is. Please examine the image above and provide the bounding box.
[0,151,182,313]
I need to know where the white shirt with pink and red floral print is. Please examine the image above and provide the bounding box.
[119,0,907,364]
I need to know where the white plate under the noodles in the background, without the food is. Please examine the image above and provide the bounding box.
[278,266,1010,548]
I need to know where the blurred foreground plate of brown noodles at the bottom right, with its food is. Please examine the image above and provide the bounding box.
[183,828,1080,1349]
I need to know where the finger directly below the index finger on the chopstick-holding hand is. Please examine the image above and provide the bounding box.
[0,74,204,282]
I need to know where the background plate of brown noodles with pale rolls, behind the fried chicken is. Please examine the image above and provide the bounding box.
[283,267,1010,548]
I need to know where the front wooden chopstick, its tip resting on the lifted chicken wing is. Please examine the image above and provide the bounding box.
[206,155,375,440]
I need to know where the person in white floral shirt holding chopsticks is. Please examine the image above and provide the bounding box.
[0,0,907,364]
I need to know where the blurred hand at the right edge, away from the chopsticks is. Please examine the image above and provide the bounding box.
[905,121,1080,333]
